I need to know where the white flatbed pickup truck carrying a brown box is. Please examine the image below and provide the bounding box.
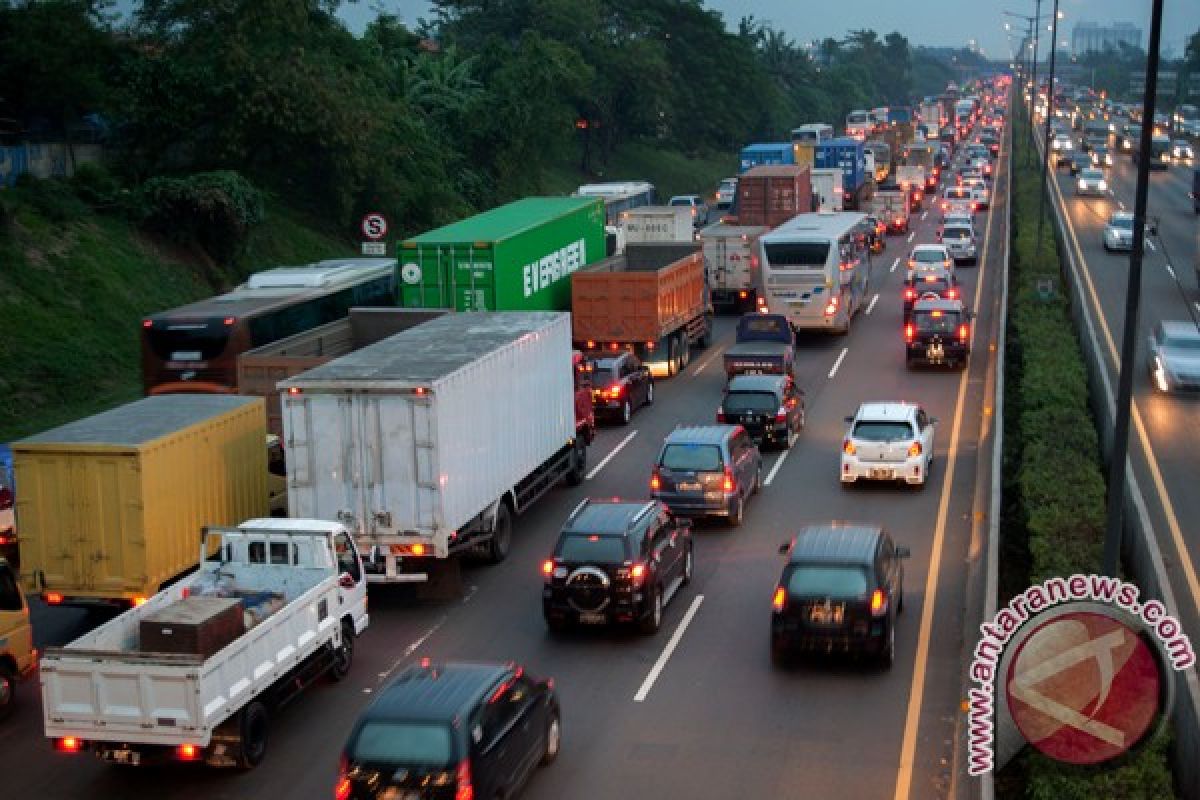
[42,519,368,769]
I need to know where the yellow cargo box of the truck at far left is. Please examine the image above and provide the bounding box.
[12,395,268,608]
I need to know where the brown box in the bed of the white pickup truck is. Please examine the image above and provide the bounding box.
[138,595,246,658]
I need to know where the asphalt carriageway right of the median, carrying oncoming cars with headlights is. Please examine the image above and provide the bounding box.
[1041,122,1200,640]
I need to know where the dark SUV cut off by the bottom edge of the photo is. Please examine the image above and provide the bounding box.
[334,660,562,800]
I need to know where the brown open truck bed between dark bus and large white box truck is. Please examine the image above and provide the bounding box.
[238,308,446,437]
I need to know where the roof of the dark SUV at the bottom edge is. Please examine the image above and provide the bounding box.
[361,661,512,722]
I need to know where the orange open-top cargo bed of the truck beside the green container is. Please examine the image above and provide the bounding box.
[571,245,706,342]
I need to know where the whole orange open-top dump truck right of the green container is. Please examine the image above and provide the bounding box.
[571,243,713,375]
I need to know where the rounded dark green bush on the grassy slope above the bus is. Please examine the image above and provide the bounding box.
[142,170,265,261]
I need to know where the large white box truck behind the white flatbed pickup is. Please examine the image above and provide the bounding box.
[280,311,585,583]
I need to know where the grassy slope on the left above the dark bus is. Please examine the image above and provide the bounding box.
[0,187,353,441]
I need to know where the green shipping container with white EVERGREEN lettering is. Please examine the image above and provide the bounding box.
[398,197,605,311]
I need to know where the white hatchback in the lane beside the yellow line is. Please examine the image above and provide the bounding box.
[840,403,937,487]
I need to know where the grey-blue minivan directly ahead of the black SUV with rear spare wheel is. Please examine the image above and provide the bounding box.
[650,425,762,527]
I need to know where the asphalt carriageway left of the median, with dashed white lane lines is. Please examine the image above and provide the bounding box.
[0,134,1007,800]
